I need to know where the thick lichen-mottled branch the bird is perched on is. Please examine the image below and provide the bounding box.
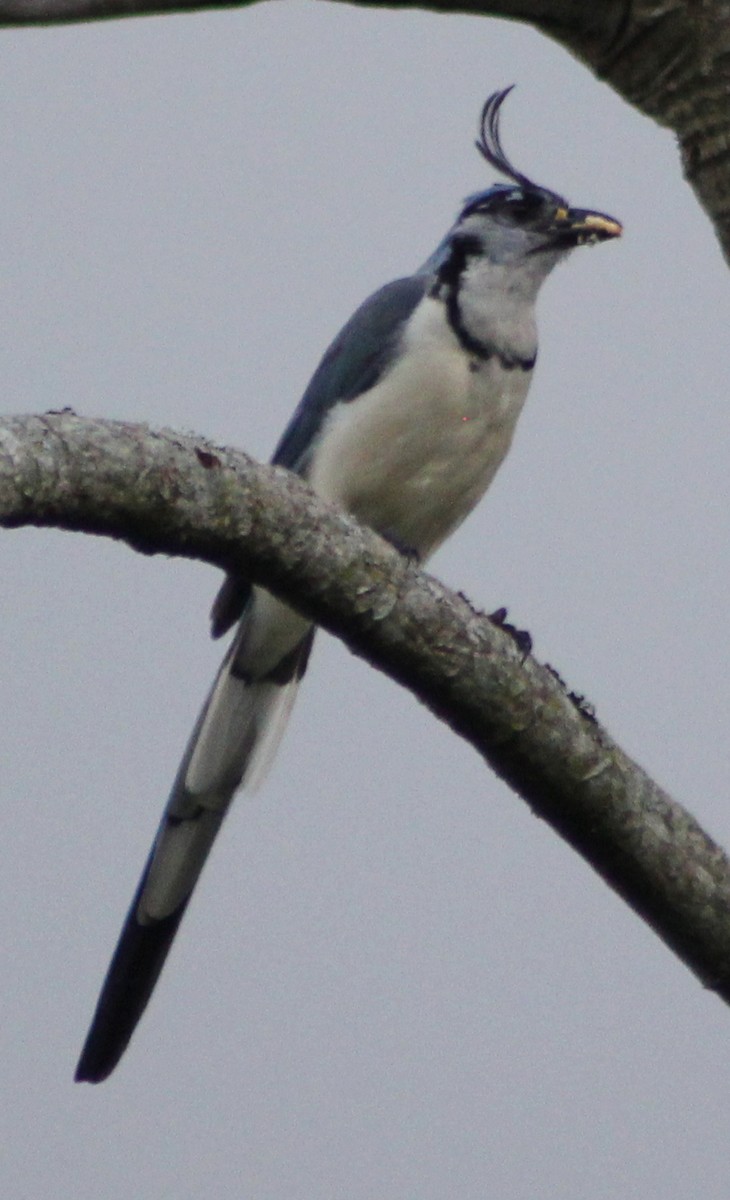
[0,412,730,1002]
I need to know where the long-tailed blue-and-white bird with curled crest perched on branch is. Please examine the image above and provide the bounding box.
[76,85,622,1082]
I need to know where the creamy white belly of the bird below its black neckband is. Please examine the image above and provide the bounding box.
[309,300,529,558]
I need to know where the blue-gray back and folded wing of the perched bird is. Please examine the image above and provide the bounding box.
[271,274,430,475]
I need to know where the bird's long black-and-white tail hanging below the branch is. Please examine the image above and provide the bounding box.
[76,589,313,1084]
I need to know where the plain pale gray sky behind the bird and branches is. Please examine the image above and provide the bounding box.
[0,9,730,1200]
